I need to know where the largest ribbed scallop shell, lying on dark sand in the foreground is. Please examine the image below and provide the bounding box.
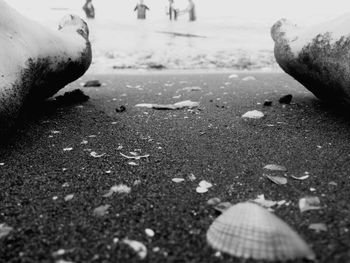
[207,202,315,261]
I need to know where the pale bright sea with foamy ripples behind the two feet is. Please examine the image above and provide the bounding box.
[7,0,350,73]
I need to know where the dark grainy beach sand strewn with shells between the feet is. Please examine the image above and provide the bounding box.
[0,73,350,263]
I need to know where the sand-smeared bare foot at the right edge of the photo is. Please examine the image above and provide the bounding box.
[271,14,350,106]
